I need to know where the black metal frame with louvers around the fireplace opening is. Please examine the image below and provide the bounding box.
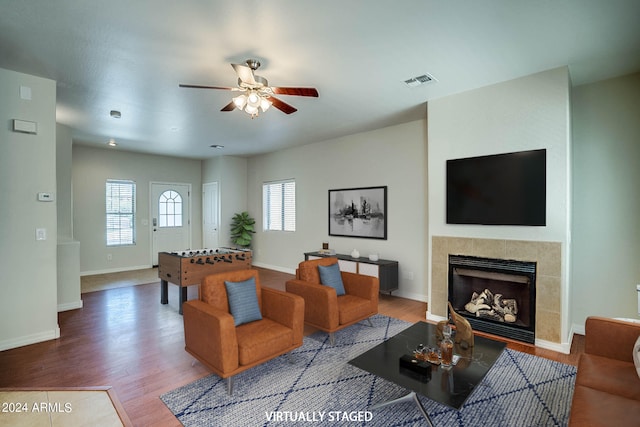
[448,254,537,344]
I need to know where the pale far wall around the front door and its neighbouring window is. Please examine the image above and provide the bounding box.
[73,145,202,274]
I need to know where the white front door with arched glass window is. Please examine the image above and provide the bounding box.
[151,183,191,265]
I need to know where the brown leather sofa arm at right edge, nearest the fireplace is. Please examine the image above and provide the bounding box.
[584,316,640,362]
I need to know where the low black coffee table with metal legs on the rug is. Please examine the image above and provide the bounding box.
[349,322,506,425]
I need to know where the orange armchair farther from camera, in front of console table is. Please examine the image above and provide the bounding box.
[286,257,380,345]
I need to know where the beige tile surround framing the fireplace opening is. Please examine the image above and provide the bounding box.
[429,236,562,343]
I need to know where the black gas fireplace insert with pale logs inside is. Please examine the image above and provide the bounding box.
[449,255,536,344]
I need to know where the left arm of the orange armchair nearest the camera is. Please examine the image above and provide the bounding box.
[182,300,239,372]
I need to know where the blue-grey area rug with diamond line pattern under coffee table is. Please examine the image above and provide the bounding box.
[160,315,576,427]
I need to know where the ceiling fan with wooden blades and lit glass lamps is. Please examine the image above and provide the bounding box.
[179,59,318,118]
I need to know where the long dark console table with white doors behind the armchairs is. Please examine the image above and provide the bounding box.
[304,251,398,295]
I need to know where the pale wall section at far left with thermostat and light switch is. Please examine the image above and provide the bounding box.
[0,69,60,350]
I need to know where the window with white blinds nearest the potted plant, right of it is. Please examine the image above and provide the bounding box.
[262,179,296,231]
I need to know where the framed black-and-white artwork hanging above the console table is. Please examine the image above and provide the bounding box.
[328,186,387,240]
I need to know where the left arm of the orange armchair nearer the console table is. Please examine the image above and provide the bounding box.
[285,279,340,330]
